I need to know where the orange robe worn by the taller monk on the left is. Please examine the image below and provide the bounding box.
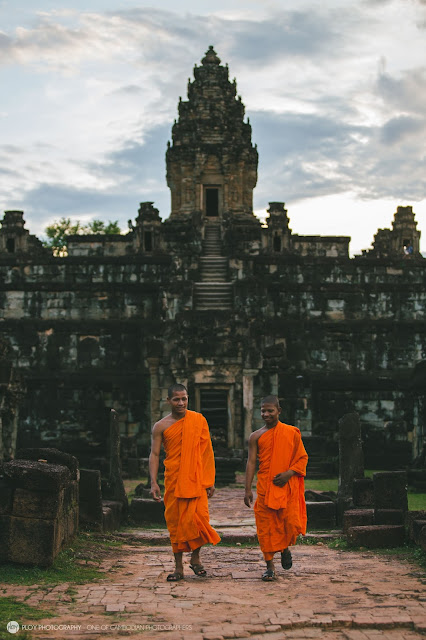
[163,410,220,553]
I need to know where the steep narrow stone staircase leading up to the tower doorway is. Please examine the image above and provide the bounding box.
[194,223,232,311]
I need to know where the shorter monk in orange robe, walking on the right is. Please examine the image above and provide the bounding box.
[244,396,308,582]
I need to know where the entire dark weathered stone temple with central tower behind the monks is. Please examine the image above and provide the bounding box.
[0,47,426,470]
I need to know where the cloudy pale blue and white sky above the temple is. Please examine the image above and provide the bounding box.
[0,0,426,254]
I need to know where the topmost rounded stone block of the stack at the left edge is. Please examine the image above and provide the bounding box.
[3,460,71,493]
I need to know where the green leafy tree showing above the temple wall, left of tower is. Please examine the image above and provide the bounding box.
[43,218,121,256]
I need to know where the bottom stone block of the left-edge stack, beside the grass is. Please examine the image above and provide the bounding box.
[8,516,61,567]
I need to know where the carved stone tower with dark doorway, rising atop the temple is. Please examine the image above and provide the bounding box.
[166,46,258,221]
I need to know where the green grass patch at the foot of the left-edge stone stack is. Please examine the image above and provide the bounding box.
[1,533,119,586]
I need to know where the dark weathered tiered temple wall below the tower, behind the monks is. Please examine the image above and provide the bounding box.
[0,229,426,464]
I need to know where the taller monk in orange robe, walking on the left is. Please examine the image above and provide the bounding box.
[149,384,220,582]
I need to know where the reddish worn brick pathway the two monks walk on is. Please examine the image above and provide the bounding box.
[0,489,426,640]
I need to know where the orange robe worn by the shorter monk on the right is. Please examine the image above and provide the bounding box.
[254,422,308,560]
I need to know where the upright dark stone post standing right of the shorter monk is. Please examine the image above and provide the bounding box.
[337,413,364,523]
